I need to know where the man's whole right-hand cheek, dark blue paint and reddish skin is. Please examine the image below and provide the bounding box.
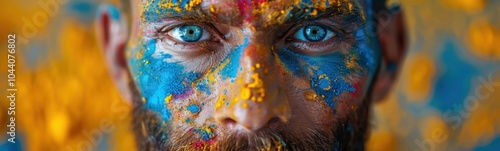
[278,40,374,115]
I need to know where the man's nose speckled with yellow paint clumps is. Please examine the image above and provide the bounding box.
[214,37,291,131]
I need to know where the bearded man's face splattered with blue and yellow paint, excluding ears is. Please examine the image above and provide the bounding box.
[127,0,379,150]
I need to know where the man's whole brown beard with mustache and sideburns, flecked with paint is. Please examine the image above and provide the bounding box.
[132,83,371,151]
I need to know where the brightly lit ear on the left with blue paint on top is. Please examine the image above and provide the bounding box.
[95,4,132,102]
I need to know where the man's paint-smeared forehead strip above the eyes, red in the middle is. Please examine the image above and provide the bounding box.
[132,0,362,26]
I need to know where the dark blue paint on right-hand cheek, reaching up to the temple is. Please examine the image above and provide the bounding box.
[278,26,380,108]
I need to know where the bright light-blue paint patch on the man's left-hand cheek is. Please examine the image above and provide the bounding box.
[130,39,200,121]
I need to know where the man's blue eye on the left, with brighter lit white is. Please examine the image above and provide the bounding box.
[168,25,210,42]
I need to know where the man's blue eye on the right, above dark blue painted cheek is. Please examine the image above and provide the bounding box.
[293,25,335,42]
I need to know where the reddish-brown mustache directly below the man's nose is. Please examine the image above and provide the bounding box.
[166,128,336,151]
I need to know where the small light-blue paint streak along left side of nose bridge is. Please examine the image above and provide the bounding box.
[220,37,249,80]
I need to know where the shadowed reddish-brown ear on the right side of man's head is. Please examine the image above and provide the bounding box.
[372,10,407,102]
